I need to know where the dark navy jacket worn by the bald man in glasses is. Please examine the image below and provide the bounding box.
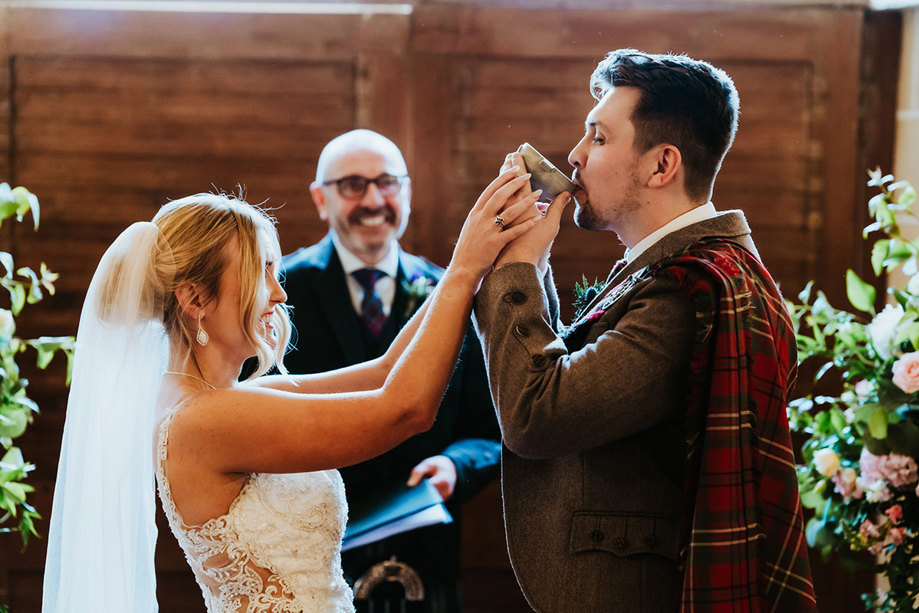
[283,236,501,578]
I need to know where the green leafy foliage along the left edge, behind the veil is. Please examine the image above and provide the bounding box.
[0,183,74,548]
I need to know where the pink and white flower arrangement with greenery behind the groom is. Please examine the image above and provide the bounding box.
[788,170,919,612]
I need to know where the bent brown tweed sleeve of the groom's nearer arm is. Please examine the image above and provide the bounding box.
[474,263,695,458]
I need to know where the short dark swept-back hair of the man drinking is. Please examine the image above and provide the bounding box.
[590,49,740,203]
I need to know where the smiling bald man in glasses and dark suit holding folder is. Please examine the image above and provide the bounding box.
[284,130,500,613]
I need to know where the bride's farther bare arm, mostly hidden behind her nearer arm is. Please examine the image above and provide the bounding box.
[250,299,431,394]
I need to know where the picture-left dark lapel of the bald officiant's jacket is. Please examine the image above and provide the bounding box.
[312,236,367,364]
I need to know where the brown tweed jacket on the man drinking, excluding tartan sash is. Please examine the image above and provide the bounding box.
[474,211,756,613]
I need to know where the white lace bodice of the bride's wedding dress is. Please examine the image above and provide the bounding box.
[156,411,354,613]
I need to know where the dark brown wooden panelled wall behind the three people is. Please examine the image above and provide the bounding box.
[0,3,900,613]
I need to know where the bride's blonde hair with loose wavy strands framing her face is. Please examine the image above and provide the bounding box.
[153,194,290,379]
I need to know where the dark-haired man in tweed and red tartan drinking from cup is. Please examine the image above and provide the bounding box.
[475,49,816,613]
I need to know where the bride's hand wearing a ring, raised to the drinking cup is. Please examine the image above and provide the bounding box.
[450,167,543,281]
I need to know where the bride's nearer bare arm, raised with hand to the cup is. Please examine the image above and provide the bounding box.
[170,173,551,473]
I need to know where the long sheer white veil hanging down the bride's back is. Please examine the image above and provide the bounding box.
[42,222,172,613]
